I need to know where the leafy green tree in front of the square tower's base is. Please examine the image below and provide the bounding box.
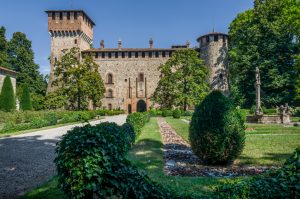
[53,48,105,110]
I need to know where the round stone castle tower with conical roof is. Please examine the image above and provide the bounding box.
[197,32,228,94]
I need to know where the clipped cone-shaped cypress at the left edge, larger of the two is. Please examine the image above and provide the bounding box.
[0,76,16,112]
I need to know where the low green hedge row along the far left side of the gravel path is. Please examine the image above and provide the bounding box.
[0,110,123,133]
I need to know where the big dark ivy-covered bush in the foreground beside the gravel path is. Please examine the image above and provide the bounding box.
[55,123,169,198]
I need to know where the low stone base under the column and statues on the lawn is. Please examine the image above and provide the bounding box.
[246,115,291,124]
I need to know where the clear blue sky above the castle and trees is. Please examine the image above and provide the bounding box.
[0,0,253,74]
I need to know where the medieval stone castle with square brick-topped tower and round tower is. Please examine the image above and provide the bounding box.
[46,10,228,113]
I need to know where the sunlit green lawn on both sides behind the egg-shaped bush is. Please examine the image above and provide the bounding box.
[166,117,300,166]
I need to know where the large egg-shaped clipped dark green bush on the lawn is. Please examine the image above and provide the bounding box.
[189,91,245,165]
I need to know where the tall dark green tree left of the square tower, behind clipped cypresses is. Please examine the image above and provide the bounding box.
[8,32,46,95]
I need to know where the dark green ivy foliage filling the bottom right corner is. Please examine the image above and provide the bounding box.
[216,148,300,199]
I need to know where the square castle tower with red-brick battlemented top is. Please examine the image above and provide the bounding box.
[46,10,95,92]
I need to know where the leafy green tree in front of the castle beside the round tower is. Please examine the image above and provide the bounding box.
[152,49,209,110]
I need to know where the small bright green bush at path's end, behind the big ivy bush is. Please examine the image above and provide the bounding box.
[126,112,150,137]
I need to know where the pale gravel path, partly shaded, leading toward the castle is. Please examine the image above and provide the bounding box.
[0,115,126,199]
